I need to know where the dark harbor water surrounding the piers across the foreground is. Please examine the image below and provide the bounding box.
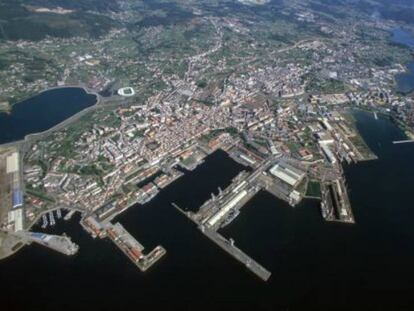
[0,112,414,310]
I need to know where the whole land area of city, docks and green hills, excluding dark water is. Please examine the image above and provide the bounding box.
[0,0,414,310]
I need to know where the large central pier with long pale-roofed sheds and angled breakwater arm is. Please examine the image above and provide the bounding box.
[172,155,307,281]
